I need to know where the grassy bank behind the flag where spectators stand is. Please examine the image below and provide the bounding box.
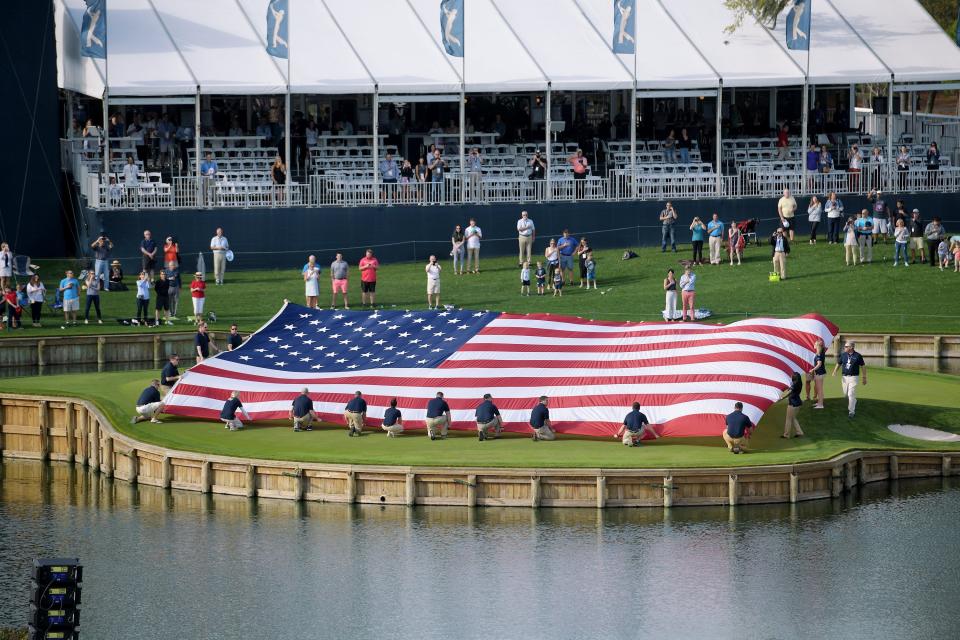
[11,237,960,337]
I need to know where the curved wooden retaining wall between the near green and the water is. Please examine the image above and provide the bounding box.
[0,394,960,509]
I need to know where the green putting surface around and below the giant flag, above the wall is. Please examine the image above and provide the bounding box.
[3,368,960,468]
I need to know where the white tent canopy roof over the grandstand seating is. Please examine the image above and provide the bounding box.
[54,0,960,97]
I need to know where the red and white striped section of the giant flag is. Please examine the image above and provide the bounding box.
[165,314,837,436]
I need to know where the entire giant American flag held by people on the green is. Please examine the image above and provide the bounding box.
[165,303,837,436]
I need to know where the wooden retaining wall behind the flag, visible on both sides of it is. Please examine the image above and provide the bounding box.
[0,329,960,372]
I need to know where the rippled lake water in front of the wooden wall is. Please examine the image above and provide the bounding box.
[0,461,960,640]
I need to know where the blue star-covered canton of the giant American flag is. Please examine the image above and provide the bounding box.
[217,304,500,373]
